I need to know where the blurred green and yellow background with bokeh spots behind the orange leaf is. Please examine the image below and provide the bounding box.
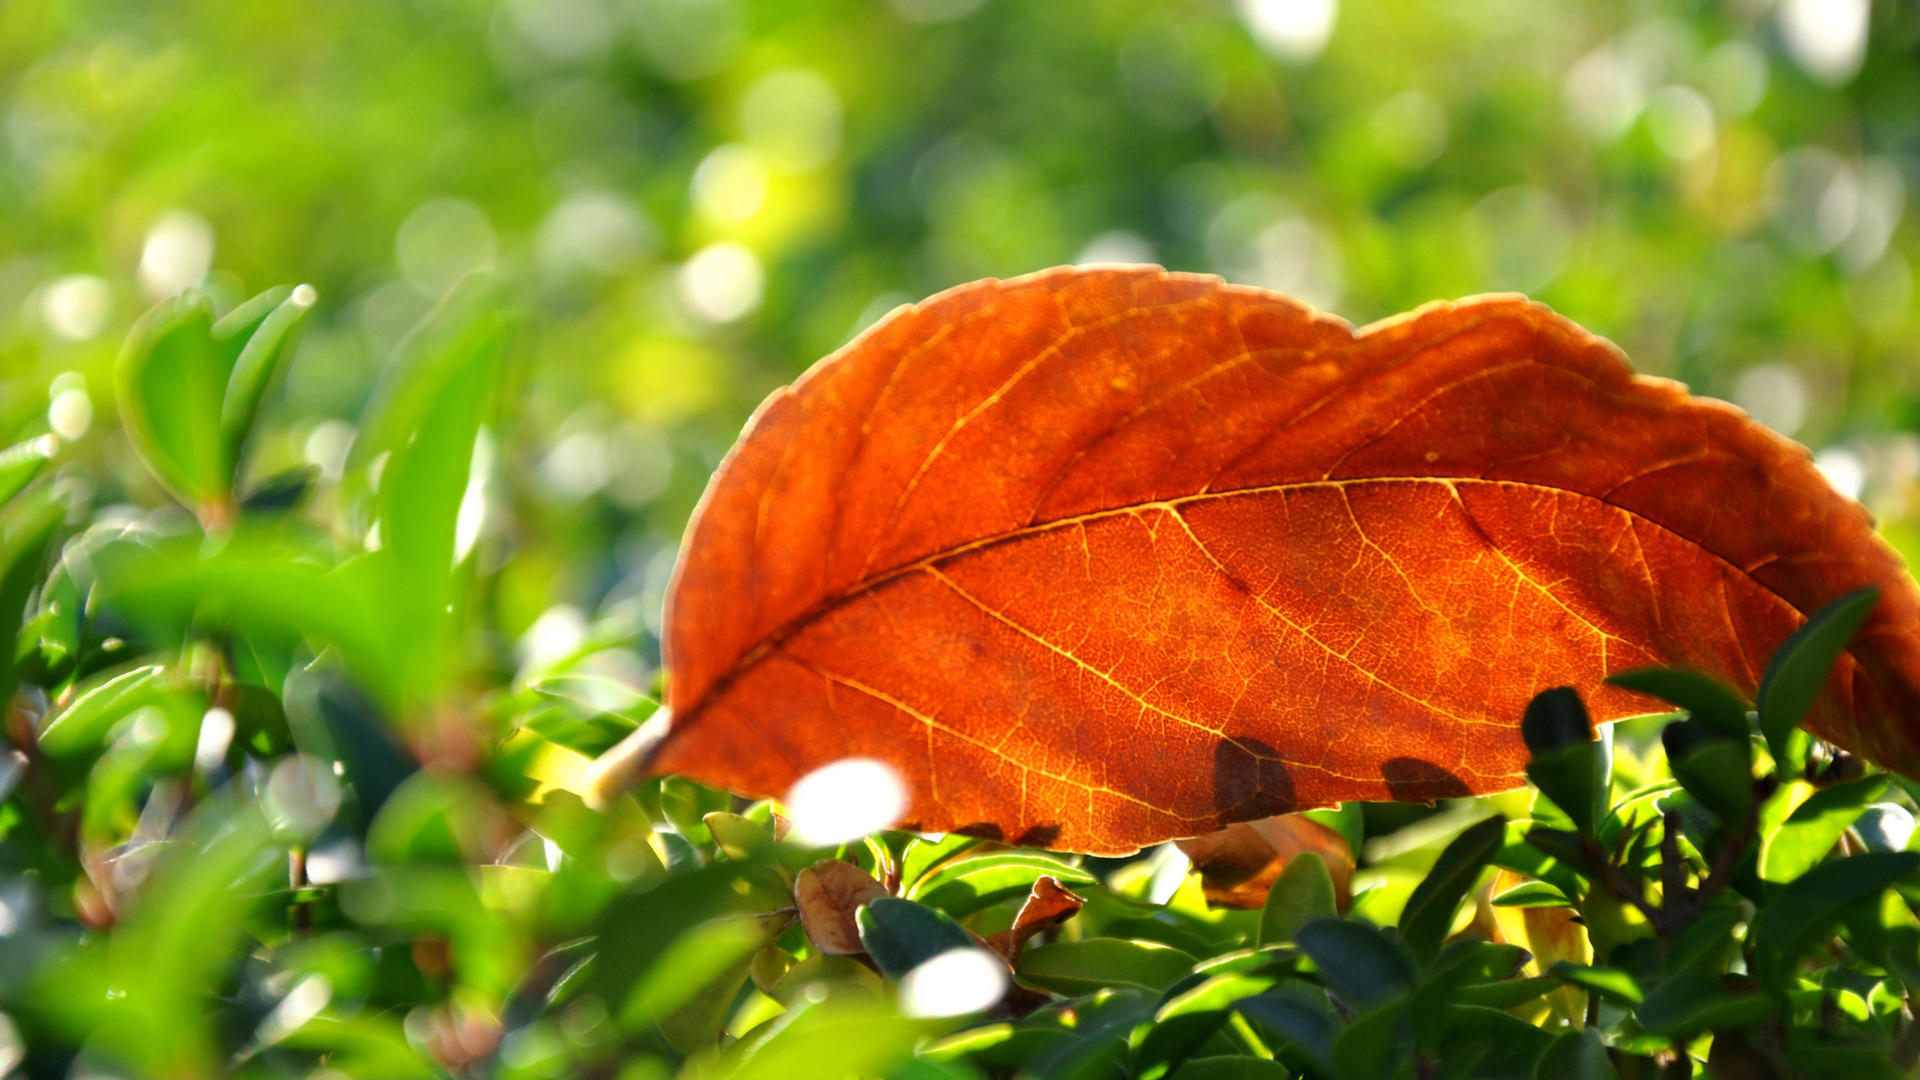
[0,0,1920,657]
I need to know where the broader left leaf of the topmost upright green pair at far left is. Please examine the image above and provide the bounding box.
[113,292,232,509]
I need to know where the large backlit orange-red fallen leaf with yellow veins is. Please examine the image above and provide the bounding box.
[633,269,1920,853]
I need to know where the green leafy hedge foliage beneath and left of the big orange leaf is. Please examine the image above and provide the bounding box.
[0,286,1920,1080]
